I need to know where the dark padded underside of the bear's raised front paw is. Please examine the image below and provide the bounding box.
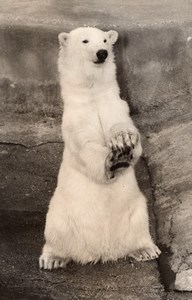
[105,147,133,179]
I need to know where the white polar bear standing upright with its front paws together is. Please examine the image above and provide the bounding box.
[39,28,160,269]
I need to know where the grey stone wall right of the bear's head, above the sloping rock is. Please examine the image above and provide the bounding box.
[117,26,192,135]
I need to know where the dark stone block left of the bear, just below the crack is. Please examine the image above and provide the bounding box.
[0,143,63,212]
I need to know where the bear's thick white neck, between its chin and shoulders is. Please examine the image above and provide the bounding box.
[59,61,119,104]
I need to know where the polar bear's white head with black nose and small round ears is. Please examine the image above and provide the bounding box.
[58,27,118,67]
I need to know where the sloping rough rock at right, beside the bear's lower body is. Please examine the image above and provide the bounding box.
[146,122,192,291]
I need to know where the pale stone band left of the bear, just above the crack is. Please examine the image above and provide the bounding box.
[0,112,63,147]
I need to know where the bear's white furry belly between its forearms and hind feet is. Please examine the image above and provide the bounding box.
[49,170,139,264]
